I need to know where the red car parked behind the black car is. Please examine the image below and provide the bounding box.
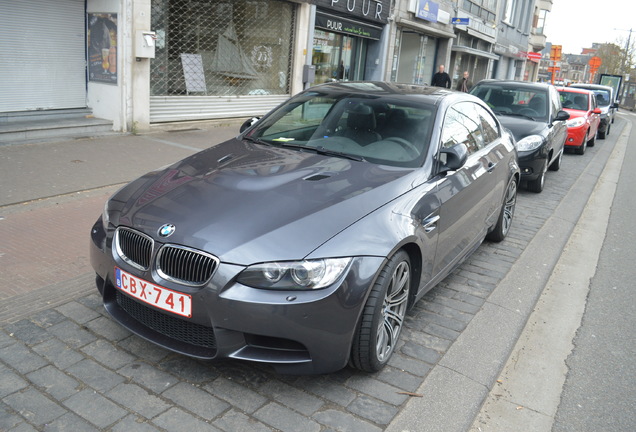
[557,87,601,154]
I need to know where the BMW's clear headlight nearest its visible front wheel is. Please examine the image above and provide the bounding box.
[237,258,351,290]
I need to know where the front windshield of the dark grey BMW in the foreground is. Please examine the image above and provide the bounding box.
[246,92,434,167]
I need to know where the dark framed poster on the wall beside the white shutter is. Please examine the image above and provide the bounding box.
[86,13,117,84]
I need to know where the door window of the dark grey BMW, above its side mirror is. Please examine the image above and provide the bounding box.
[442,102,484,154]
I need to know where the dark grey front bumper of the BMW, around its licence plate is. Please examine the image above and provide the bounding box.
[90,219,384,374]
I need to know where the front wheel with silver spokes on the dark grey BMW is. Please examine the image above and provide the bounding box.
[349,251,411,372]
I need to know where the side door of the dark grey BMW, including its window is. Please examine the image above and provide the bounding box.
[433,102,498,275]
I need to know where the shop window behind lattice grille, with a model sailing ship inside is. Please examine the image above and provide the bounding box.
[150,0,295,96]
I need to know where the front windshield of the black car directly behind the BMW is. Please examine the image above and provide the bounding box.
[470,85,549,120]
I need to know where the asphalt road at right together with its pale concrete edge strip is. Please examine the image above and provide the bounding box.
[471,113,636,432]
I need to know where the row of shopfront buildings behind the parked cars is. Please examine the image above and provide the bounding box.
[0,0,547,132]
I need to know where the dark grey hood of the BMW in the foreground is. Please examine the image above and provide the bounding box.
[109,139,425,265]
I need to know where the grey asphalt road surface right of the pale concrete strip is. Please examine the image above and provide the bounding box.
[552,116,636,432]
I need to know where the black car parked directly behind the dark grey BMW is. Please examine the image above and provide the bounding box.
[470,80,570,192]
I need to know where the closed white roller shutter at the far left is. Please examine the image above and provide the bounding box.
[0,0,86,112]
